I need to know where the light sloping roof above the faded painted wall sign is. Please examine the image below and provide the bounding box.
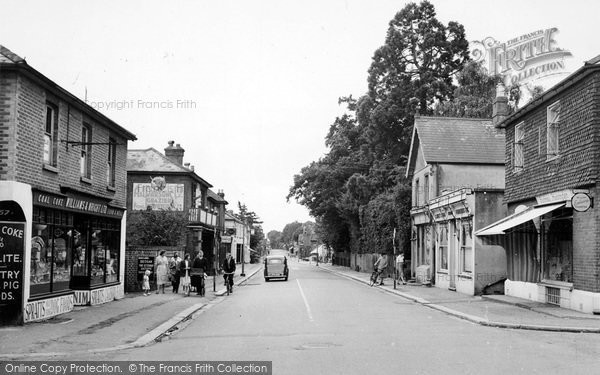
[127,147,212,187]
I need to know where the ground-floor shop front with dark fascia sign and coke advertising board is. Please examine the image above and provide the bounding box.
[0,182,125,323]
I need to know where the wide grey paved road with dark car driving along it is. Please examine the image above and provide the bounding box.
[78,261,600,374]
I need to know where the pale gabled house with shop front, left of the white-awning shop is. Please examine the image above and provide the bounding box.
[405,117,506,295]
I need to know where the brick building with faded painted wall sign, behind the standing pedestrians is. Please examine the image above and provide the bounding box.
[127,141,227,291]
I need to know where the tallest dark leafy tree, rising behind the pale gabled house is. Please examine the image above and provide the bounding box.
[368,1,469,162]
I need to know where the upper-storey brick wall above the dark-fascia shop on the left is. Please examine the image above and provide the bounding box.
[14,75,127,206]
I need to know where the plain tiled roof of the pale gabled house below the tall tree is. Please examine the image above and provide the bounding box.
[413,117,505,164]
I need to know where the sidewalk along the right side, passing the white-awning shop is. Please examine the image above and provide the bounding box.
[319,263,600,333]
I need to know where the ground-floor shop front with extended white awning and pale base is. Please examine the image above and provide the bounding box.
[476,189,600,313]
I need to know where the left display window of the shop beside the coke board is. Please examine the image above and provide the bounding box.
[30,208,73,295]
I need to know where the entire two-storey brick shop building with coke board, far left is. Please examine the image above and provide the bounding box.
[0,46,136,323]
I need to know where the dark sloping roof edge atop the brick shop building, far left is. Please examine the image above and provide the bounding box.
[0,44,137,141]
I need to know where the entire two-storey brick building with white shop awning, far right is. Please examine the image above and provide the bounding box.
[476,58,600,312]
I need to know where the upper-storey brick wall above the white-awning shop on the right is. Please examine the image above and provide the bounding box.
[505,73,600,202]
